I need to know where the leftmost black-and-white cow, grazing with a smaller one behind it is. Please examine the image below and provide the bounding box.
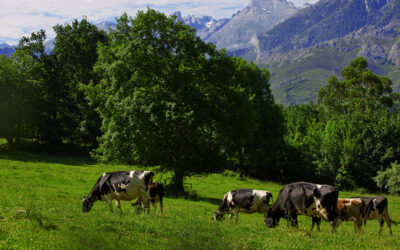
[82,171,154,213]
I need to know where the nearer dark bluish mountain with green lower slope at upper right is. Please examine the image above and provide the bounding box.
[257,0,400,104]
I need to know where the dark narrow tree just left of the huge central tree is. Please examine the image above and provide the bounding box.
[46,18,107,146]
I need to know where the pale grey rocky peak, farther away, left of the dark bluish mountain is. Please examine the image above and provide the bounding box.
[205,0,298,60]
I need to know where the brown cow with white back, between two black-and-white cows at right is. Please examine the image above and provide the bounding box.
[336,198,366,231]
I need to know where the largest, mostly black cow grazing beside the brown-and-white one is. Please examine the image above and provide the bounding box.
[264,182,339,231]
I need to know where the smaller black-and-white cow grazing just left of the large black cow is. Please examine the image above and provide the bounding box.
[212,189,272,222]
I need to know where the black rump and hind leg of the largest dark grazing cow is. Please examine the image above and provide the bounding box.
[314,188,339,230]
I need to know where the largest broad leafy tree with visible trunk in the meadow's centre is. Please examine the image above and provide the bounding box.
[88,9,280,190]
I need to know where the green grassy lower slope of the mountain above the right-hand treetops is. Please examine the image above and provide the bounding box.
[259,49,400,105]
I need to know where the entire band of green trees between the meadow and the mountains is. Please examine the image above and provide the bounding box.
[0,9,400,194]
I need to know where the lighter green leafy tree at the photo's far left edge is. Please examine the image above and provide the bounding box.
[0,30,46,147]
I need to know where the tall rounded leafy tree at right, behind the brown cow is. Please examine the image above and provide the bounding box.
[315,58,400,189]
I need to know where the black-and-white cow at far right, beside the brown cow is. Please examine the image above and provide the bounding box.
[353,196,398,234]
